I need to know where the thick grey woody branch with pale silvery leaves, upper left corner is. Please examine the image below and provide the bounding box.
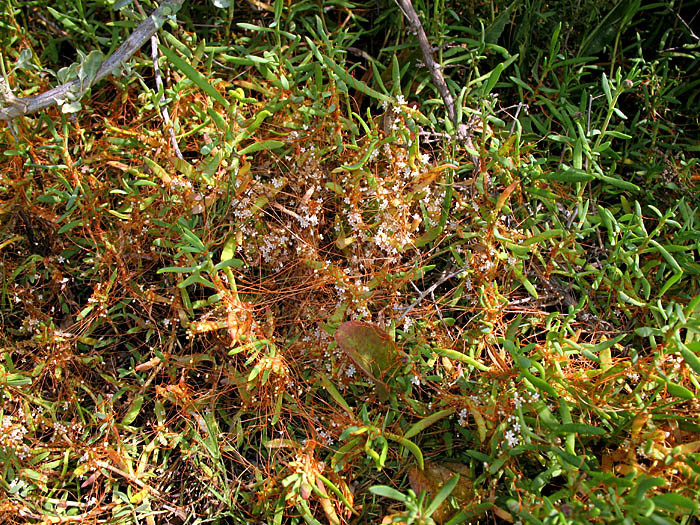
[0,0,184,120]
